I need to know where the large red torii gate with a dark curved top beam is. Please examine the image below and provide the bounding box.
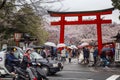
[48,8,114,51]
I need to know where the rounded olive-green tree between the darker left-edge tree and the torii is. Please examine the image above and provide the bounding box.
[14,7,47,43]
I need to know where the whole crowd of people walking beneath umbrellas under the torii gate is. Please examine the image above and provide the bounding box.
[36,44,115,67]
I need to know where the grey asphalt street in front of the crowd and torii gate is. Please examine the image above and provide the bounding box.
[1,59,120,80]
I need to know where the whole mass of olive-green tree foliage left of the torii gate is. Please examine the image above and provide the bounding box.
[0,0,48,44]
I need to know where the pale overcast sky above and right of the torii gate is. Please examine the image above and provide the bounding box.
[40,0,120,23]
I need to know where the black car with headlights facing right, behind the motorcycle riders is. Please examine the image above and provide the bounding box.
[31,52,63,74]
